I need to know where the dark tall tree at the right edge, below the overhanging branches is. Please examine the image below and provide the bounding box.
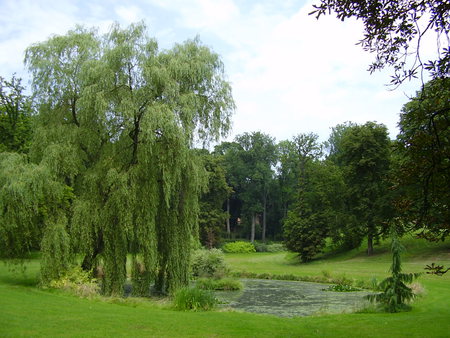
[396,78,450,240]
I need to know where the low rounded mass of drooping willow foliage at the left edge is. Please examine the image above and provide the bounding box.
[0,153,72,266]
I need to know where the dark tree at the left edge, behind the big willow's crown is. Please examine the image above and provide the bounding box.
[0,75,32,153]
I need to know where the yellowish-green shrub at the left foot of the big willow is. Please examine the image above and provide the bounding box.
[49,266,100,297]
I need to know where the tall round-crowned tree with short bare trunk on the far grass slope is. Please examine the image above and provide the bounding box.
[338,122,391,255]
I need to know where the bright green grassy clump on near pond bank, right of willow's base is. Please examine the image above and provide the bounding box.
[173,288,217,311]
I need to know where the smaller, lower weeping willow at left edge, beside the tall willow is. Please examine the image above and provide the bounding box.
[0,153,73,283]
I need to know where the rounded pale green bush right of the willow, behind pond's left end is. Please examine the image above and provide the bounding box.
[191,249,228,278]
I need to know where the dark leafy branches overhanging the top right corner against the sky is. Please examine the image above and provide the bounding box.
[310,0,450,85]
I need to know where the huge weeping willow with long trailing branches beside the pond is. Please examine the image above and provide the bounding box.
[2,24,234,294]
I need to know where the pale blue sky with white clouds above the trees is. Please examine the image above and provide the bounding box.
[0,0,421,141]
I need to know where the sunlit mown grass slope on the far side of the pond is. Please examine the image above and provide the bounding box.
[226,235,450,284]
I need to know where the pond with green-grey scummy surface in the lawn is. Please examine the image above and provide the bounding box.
[216,279,370,317]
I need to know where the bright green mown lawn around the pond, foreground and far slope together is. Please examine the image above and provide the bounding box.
[0,236,450,337]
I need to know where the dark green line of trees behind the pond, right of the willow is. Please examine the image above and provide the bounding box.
[200,96,449,261]
